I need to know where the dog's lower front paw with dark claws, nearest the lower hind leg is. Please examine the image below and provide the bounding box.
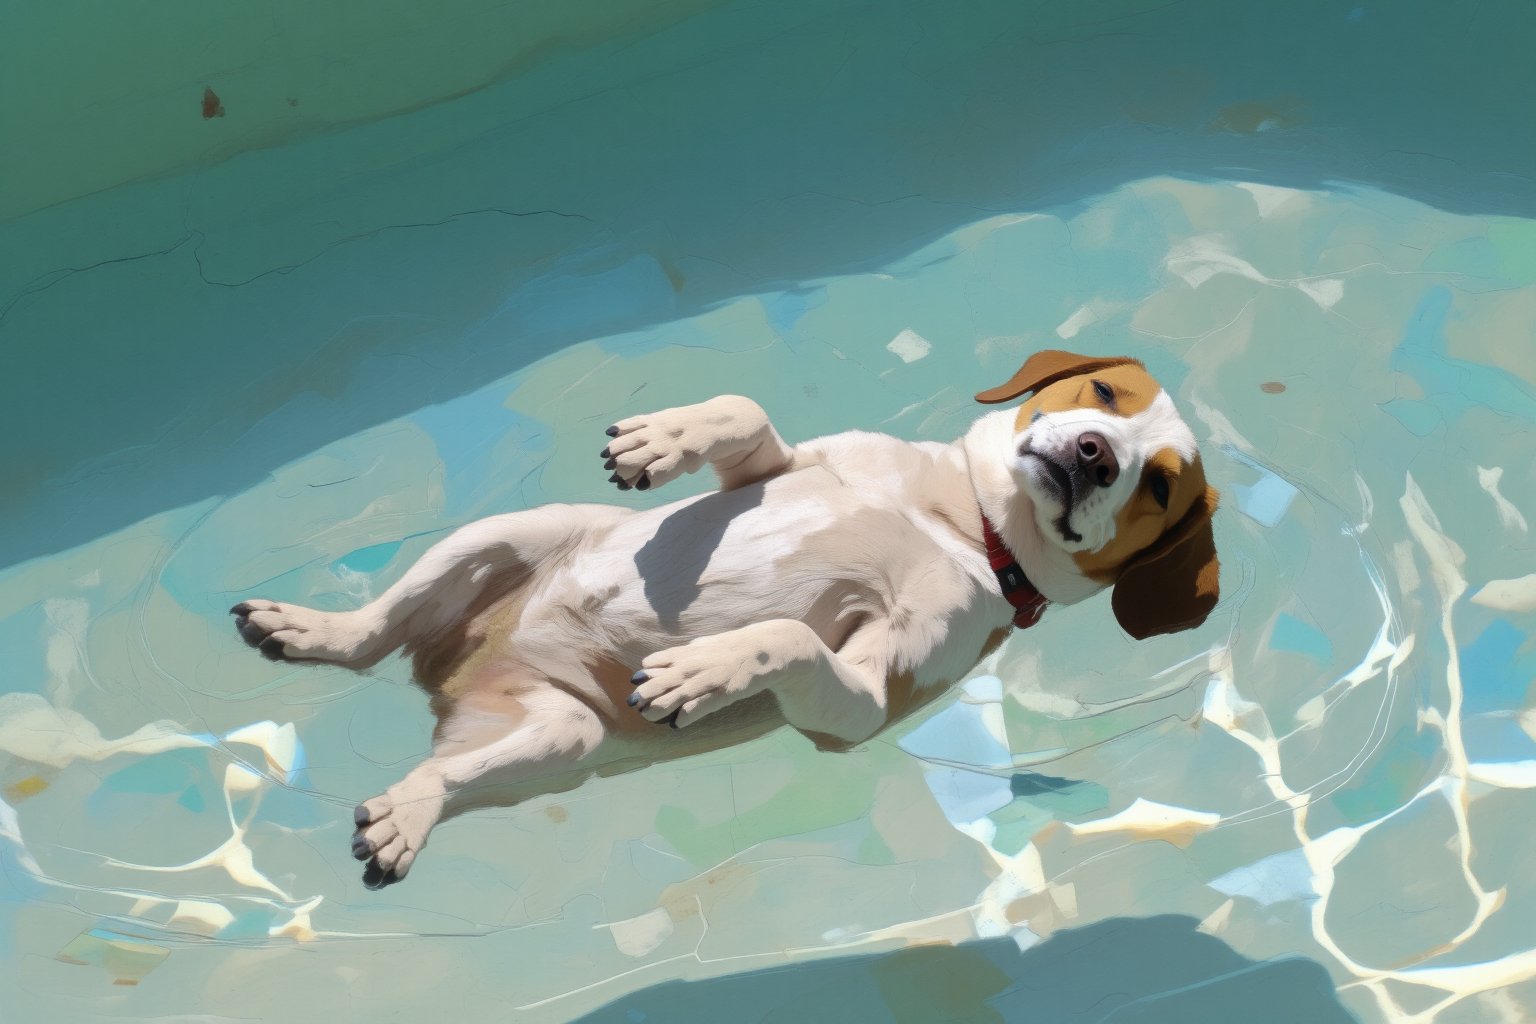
[630,637,768,729]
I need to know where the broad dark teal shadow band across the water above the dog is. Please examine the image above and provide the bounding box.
[0,0,1536,565]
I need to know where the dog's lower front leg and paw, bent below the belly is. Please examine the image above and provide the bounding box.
[630,619,889,743]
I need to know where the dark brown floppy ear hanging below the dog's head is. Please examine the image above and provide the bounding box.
[1111,487,1221,640]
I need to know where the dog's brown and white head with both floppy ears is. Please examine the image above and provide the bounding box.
[975,350,1218,640]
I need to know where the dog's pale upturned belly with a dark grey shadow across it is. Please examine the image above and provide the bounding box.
[465,467,946,697]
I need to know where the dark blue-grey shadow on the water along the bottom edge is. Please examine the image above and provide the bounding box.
[568,915,1355,1024]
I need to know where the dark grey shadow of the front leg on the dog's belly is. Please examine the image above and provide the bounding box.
[634,484,765,633]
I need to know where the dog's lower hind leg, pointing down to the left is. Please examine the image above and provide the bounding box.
[352,685,604,889]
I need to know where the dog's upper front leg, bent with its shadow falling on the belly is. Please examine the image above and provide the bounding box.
[601,395,794,491]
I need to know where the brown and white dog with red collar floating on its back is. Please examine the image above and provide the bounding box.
[230,350,1218,889]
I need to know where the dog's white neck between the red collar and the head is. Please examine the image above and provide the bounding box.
[955,410,1103,605]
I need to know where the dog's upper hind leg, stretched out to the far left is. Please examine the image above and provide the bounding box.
[230,505,611,668]
